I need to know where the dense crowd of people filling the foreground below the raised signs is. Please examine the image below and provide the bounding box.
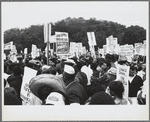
[3,52,148,105]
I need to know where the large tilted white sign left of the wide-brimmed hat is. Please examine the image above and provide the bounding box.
[20,67,37,103]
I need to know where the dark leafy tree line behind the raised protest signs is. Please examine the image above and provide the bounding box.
[4,17,146,52]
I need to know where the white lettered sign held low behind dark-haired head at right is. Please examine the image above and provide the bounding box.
[116,64,130,98]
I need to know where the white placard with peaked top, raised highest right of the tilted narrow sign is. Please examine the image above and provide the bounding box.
[106,36,118,54]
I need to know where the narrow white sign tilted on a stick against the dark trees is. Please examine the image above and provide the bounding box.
[87,32,96,46]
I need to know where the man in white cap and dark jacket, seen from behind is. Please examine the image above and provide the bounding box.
[63,64,87,105]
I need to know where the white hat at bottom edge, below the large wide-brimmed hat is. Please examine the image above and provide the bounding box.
[45,92,65,105]
